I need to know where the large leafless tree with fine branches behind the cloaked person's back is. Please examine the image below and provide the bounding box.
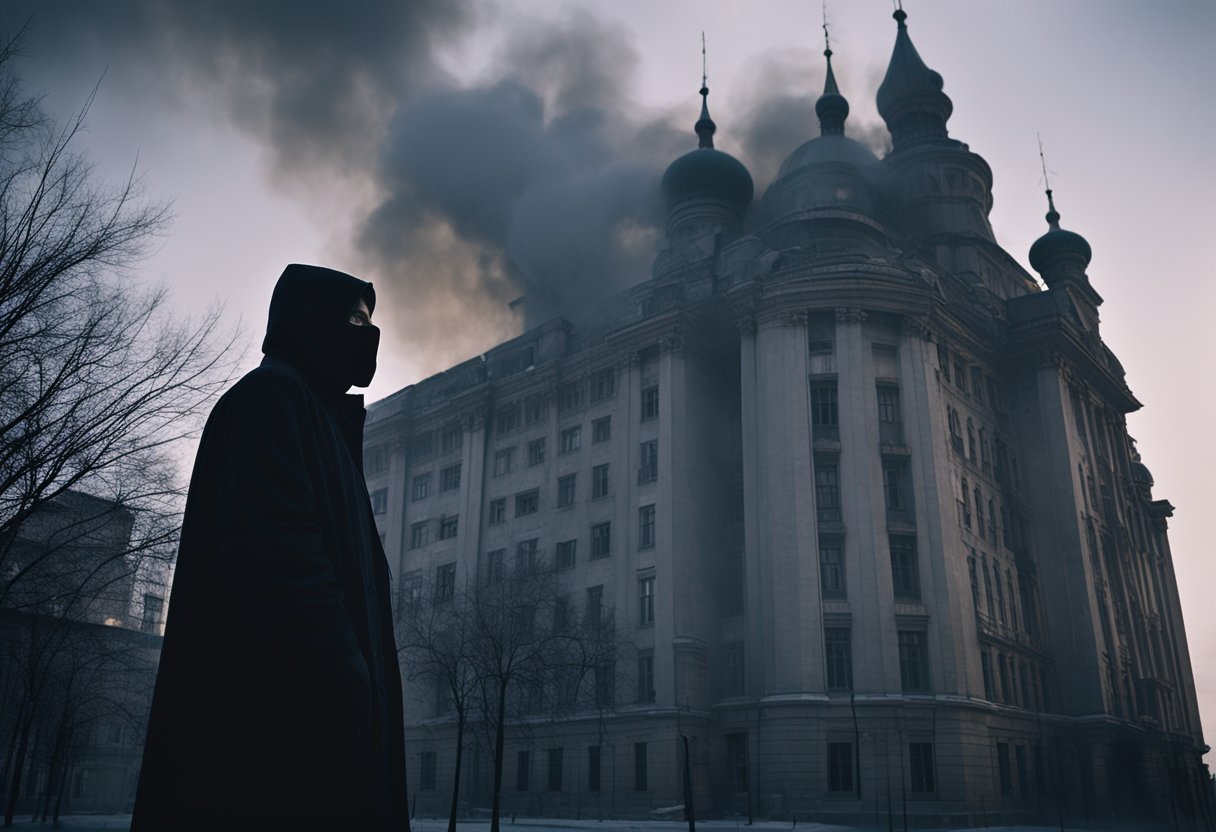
[0,33,236,825]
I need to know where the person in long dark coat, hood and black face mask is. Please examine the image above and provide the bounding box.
[131,265,409,832]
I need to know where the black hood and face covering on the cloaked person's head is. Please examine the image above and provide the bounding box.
[261,263,379,393]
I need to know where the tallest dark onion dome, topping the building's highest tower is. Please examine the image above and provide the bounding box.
[878,9,955,147]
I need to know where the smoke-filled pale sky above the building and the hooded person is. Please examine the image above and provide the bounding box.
[7,0,1216,754]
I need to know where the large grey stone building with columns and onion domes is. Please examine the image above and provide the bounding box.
[366,11,1211,825]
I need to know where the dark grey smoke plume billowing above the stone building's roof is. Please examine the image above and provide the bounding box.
[0,0,885,370]
